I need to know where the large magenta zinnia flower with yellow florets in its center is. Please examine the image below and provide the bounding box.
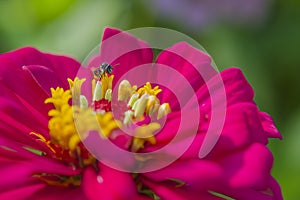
[0,29,282,199]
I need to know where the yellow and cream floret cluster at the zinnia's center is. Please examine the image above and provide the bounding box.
[30,65,171,186]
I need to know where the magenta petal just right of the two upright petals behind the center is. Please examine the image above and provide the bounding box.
[186,68,255,134]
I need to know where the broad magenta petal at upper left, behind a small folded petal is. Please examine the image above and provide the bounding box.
[0,47,80,117]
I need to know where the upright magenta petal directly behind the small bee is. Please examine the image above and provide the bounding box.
[88,28,153,85]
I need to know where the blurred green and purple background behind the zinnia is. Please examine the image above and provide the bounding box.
[0,0,300,200]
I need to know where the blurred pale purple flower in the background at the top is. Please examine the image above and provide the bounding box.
[146,0,271,30]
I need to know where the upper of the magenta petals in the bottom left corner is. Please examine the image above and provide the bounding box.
[0,148,80,191]
